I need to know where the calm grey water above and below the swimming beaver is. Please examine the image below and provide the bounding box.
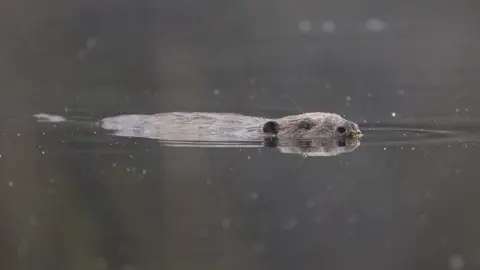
[0,0,480,269]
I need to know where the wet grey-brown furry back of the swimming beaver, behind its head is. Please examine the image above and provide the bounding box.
[99,112,268,141]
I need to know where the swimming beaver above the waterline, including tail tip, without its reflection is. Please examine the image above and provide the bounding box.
[35,112,362,141]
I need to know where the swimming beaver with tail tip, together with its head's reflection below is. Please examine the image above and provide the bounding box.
[34,112,362,156]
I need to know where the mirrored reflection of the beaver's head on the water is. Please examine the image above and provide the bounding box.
[263,137,360,156]
